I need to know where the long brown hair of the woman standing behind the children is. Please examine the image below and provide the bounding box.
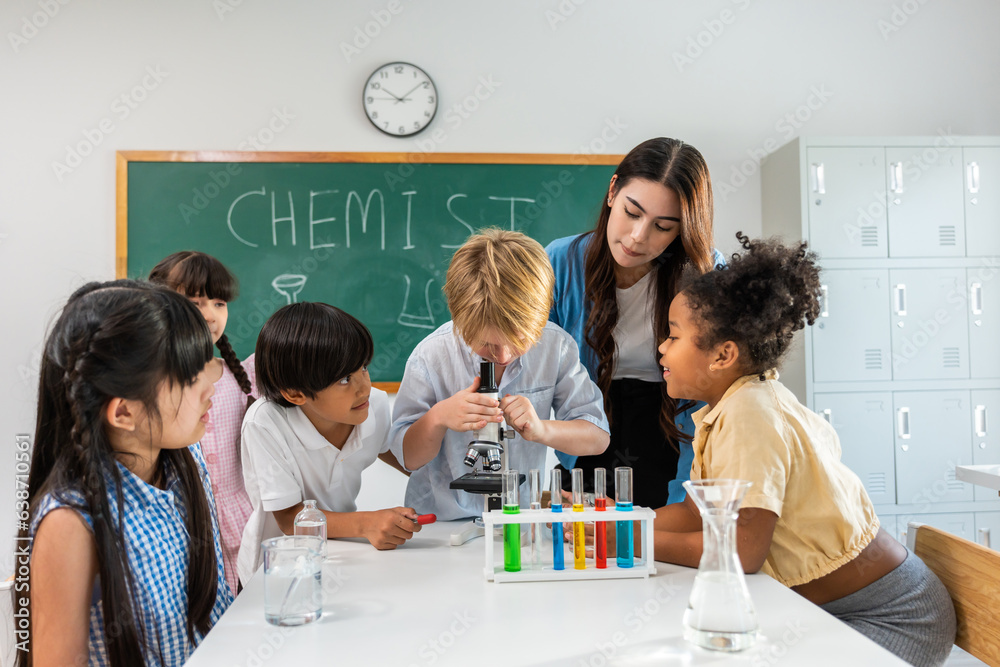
[574,137,713,447]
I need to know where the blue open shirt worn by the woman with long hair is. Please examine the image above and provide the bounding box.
[545,232,726,504]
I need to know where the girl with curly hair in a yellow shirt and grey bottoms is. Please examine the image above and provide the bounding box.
[654,234,955,665]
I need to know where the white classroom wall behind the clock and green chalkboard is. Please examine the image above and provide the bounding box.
[0,0,1000,574]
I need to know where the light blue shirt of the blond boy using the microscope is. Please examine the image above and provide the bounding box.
[389,322,608,521]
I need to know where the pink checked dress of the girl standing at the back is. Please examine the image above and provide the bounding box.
[201,355,257,592]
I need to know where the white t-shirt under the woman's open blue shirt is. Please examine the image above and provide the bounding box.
[612,271,663,382]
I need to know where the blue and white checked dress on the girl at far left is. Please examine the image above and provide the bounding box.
[31,444,233,667]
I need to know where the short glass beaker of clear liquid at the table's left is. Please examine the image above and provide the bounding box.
[261,535,323,625]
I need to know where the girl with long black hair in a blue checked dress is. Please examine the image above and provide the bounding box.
[15,281,232,667]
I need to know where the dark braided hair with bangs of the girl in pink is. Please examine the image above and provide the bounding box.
[149,250,251,396]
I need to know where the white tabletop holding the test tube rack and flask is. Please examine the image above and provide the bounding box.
[187,523,905,667]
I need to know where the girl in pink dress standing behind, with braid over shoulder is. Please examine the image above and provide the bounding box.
[149,250,257,593]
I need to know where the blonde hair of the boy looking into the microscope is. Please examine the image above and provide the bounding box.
[444,228,555,353]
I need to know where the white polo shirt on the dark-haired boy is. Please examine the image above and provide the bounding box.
[237,387,392,583]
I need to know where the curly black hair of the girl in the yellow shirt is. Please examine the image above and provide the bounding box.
[681,232,821,375]
